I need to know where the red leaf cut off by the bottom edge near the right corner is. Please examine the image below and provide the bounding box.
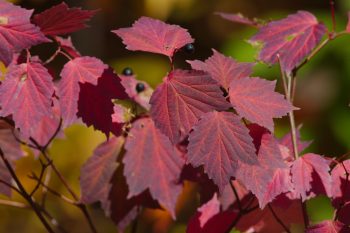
[306,220,350,233]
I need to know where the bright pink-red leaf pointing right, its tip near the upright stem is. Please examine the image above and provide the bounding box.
[229,78,293,132]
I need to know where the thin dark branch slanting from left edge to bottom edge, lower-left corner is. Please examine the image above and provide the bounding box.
[0,148,54,233]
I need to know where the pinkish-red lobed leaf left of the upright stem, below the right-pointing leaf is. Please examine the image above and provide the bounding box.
[236,134,292,208]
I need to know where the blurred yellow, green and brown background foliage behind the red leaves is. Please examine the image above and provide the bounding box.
[0,0,350,233]
